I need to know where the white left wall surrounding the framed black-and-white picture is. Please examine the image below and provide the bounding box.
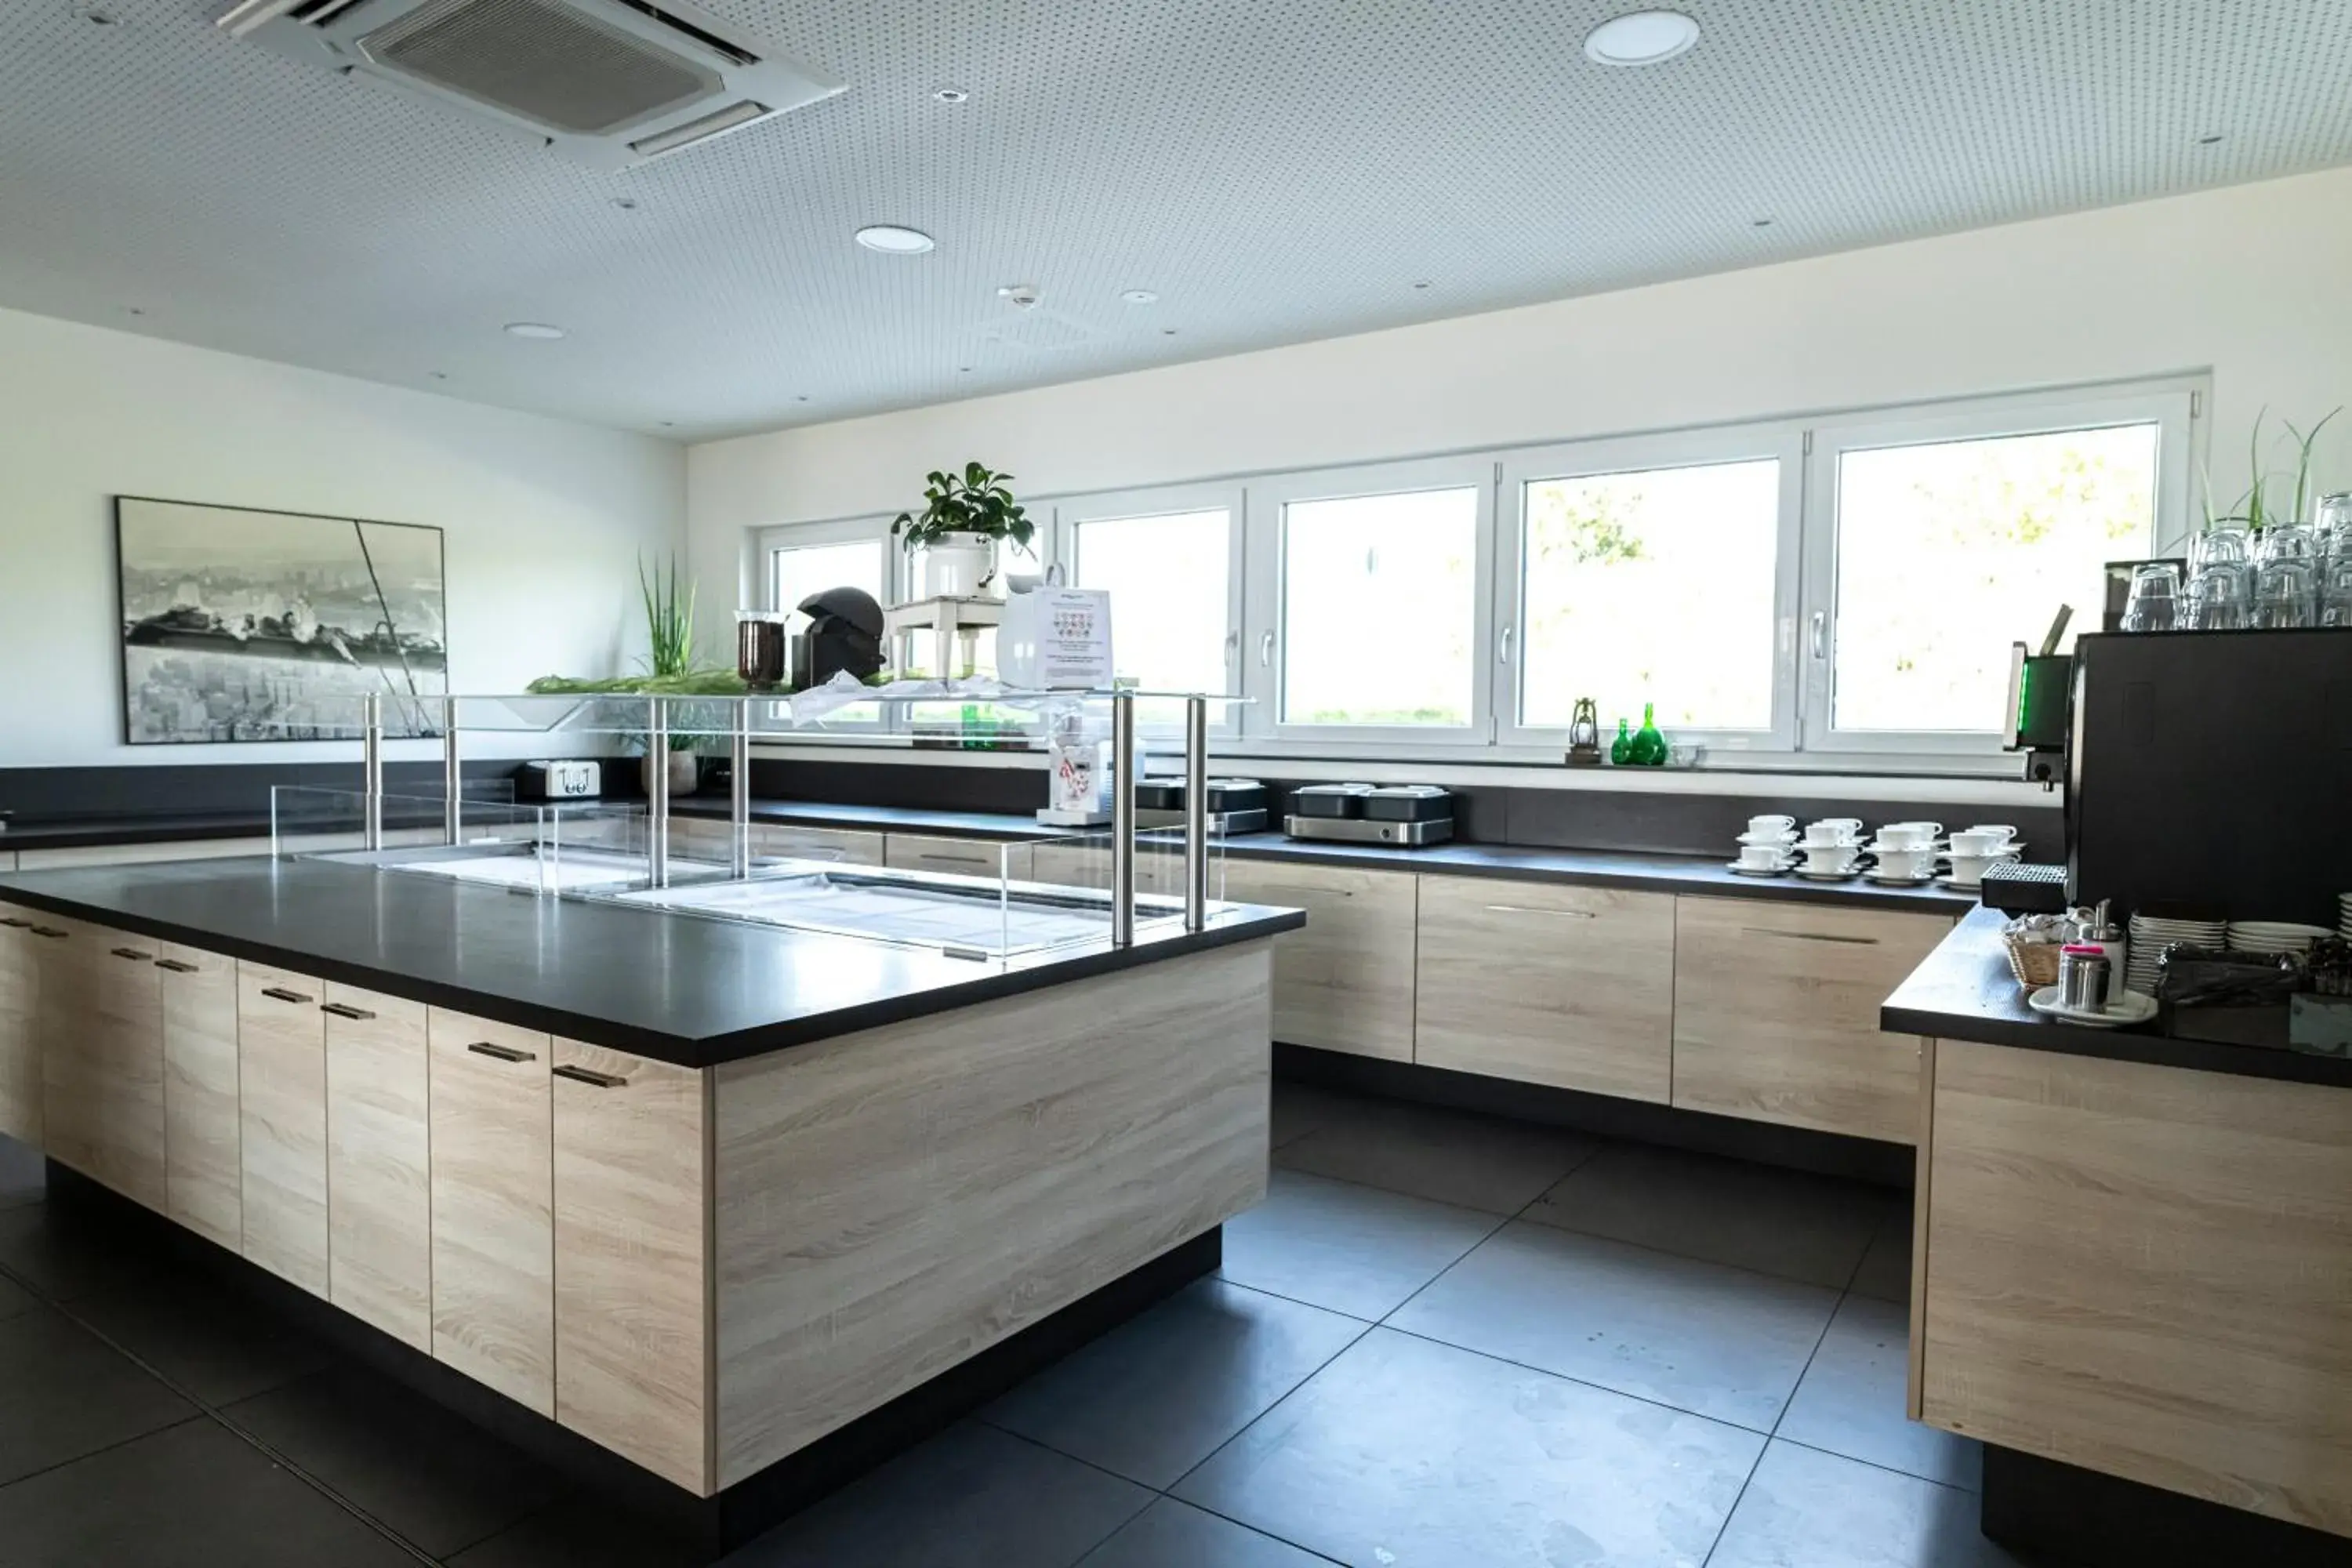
[0,310,687,767]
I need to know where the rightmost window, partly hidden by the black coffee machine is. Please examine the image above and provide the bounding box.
[1806,393,2187,750]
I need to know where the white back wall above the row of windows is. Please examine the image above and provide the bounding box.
[687,169,2352,616]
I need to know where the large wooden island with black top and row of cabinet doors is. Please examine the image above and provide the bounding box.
[0,858,1303,1549]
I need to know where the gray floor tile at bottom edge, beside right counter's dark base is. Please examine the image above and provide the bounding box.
[1708,1443,2018,1568]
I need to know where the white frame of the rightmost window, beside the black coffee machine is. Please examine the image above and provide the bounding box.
[1797,379,2204,757]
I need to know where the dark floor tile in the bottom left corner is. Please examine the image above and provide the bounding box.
[0,1420,416,1568]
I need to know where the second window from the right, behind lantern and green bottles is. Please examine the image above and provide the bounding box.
[1501,430,1802,746]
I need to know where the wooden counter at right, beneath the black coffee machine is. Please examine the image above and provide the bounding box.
[1882,909,2352,1568]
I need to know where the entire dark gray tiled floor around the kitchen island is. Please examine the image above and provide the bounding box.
[0,1088,2011,1568]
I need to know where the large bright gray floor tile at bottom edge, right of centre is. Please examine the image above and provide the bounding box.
[1174,1328,1764,1568]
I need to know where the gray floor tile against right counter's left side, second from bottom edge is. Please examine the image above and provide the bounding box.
[1778,1295,1983,1490]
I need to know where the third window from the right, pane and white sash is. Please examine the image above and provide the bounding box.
[1249,459,1494,741]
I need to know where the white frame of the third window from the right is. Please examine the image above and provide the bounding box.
[1240,452,1496,755]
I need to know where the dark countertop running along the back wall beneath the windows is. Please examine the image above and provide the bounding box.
[673,797,1976,914]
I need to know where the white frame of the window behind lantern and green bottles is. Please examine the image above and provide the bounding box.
[1489,421,1804,753]
